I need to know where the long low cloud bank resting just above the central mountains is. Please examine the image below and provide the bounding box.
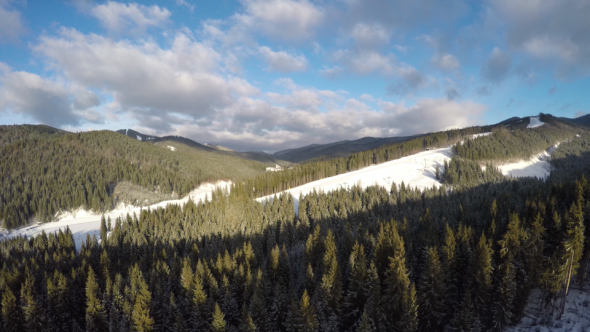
[163,96,485,151]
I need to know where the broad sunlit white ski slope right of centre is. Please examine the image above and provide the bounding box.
[256,147,452,211]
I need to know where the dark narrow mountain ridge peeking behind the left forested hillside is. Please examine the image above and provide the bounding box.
[117,129,292,167]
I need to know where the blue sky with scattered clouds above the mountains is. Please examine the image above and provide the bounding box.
[0,0,590,152]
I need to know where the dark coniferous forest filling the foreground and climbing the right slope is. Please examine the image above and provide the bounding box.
[0,115,590,332]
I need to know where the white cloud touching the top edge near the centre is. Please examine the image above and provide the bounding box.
[235,0,324,41]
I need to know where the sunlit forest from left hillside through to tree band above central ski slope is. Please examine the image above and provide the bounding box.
[0,125,487,228]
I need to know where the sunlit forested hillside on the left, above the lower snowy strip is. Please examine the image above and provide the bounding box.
[0,126,265,227]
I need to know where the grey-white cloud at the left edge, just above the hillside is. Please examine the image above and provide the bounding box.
[0,67,102,127]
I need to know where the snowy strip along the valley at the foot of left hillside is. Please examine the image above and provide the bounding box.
[0,181,231,250]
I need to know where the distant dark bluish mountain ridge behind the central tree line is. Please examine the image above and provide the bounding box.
[273,135,421,163]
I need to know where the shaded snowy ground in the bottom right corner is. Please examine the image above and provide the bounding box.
[506,278,590,332]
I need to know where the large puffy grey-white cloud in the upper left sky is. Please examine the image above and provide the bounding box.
[34,29,258,118]
